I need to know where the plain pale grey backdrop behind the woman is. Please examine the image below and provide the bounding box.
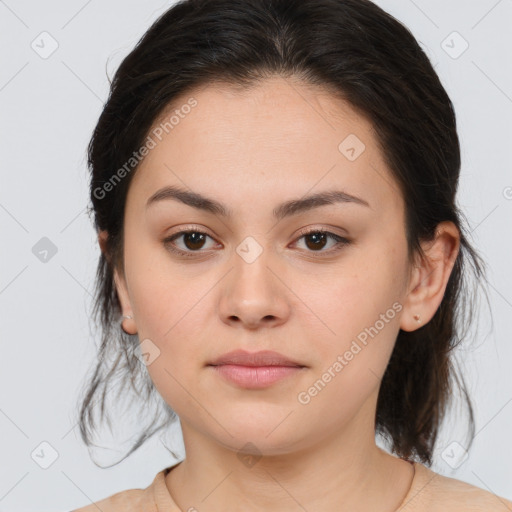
[0,0,512,512]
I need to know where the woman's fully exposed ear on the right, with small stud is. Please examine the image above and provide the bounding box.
[400,221,460,331]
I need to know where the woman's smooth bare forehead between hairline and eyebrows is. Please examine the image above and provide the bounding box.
[129,78,400,218]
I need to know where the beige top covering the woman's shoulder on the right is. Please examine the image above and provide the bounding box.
[399,462,512,512]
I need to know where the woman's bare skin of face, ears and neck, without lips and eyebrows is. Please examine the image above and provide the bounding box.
[99,77,459,512]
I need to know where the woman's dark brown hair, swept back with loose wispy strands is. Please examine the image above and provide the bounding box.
[79,0,484,465]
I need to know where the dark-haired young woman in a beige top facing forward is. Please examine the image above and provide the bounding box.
[71,0,512,512]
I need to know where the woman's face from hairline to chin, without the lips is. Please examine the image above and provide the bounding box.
[116,78,416,454]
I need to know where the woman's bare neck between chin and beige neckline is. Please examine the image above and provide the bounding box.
[166,394,414,512]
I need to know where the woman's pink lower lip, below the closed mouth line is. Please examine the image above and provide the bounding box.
[209,364,303,389]
